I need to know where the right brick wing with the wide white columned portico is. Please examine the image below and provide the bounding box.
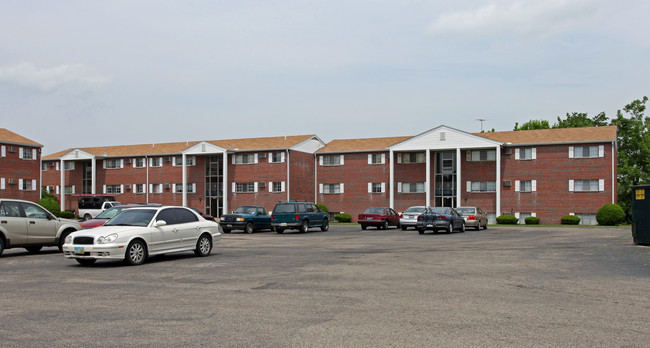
[316,126,617,224]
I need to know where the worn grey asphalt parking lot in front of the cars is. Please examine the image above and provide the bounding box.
[0,225,650,347]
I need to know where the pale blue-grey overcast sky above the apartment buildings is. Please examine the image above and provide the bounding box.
[0,0,650,155]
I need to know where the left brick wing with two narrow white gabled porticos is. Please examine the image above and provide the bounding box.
[43,135,325,216]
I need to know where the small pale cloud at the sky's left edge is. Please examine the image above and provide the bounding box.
[0,62,108,92]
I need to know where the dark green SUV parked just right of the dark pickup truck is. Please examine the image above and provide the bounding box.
[271,201,330,233]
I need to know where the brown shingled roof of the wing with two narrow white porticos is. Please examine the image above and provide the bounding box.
[43,135,315,160]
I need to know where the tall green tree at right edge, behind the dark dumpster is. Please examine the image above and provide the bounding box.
[612,97,650,220]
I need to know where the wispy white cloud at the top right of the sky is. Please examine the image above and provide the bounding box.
[429,0,599,36]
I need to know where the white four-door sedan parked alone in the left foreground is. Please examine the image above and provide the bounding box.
[63,206,221,265]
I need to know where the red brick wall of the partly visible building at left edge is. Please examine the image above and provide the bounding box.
[0,144,41,202]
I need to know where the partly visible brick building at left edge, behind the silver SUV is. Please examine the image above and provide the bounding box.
[0,128,43,202]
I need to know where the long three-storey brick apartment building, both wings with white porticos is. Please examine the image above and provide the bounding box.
[42,126,617,224]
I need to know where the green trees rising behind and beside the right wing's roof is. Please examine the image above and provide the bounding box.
[514,97,650,221]
